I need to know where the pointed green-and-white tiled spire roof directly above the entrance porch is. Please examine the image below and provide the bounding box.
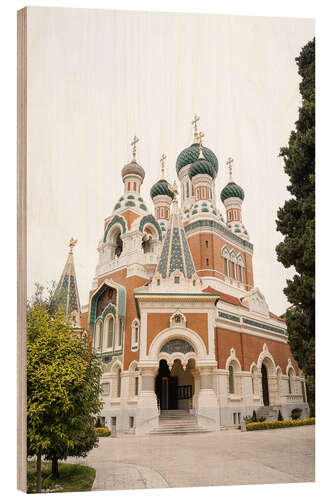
[156,199,195,278]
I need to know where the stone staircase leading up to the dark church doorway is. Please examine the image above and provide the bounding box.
[149,410,210,434]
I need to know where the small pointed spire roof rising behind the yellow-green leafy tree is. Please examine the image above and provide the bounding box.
[55,238,81,315]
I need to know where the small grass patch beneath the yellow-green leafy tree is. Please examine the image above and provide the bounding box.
[27,460,96,493]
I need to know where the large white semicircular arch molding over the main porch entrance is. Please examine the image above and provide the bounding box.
[148,327,207,360]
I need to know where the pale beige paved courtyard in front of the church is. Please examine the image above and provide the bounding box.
[69,425,315,490]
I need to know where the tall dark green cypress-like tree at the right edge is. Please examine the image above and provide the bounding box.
[276,39,315,411]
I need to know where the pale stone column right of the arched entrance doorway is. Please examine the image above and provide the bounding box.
[197,366,219,429]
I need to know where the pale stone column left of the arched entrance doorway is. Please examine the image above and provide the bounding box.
[136,366,159,434]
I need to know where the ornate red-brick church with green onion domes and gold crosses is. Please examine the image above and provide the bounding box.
[58,117,309,434]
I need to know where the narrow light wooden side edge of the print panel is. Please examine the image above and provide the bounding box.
[17,8,27,492]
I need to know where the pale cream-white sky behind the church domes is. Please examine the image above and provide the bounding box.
[27,7,314,314]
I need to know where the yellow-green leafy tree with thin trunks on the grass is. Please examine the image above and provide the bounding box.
[27,285,102,491]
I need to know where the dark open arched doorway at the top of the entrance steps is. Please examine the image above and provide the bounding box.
[155,359,194,410]
